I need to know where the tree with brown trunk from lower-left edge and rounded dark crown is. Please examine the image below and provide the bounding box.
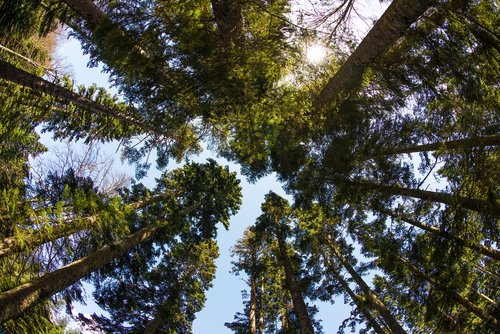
[0,160,240,322]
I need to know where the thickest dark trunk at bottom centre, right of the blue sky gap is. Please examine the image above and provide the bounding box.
[276,228,314,334]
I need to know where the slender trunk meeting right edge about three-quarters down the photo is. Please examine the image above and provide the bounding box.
[368,205,500,261]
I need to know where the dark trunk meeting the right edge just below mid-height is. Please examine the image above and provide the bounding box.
[344,179,500,215]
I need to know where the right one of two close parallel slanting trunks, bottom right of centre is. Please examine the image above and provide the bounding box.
[323,238,406,334]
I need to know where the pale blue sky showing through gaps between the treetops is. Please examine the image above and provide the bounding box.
[47,1,388,334]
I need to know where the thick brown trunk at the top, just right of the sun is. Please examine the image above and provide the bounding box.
[315,0,435,107]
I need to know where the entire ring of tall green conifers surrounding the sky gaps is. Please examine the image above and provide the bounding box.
[0,0,500,334]
